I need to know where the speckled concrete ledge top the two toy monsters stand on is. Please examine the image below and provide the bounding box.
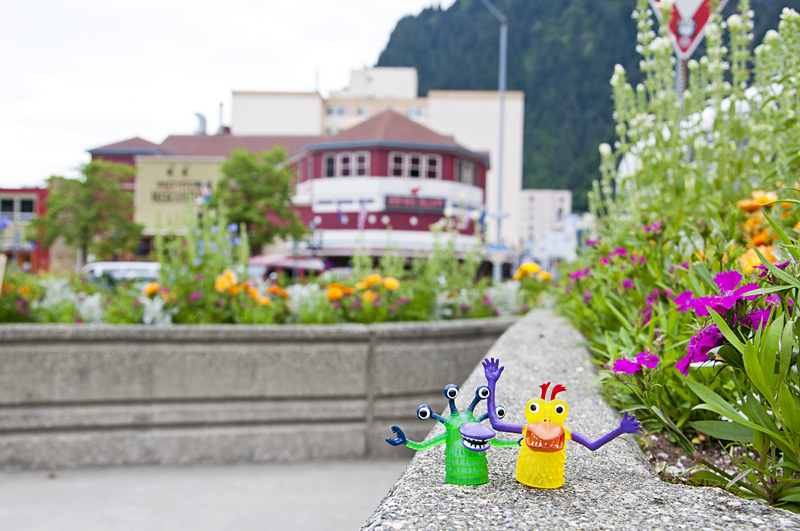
[363,310,800,530]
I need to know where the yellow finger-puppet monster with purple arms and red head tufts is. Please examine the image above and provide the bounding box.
[483,358,642,489]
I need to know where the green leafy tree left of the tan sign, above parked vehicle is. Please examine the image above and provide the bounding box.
[28,160,143,266]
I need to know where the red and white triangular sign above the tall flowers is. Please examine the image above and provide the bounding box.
[650,0,728,60]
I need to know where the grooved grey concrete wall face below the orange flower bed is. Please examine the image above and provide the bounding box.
[0,318,516,469]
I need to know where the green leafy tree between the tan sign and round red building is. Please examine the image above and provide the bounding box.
[209,148,307,249]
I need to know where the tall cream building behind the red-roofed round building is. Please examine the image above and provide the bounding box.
[231,68,525,247]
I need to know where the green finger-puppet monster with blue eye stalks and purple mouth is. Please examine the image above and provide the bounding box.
[386,384,519,485]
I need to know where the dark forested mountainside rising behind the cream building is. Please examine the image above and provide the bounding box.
[376,0,800,210]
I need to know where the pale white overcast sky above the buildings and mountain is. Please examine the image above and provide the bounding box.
[0,0,455,188]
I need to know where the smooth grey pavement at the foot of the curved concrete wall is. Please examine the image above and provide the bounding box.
[0,460,408,531]
